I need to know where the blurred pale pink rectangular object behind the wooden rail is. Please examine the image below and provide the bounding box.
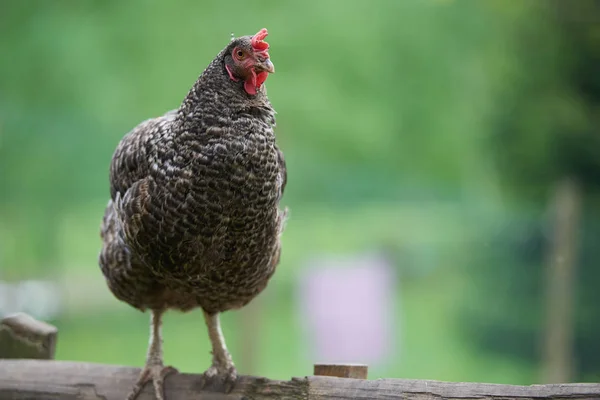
[300,255,396,364]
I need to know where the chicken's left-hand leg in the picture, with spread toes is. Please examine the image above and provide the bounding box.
[127,310,177,400]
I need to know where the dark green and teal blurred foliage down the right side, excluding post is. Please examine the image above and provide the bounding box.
[464,0,600,379]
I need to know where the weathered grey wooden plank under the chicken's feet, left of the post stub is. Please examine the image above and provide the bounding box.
[0,360,308,400]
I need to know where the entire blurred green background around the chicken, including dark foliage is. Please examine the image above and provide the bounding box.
[0,0,600,384]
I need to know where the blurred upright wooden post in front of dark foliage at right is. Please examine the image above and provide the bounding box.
[542,178,581,383]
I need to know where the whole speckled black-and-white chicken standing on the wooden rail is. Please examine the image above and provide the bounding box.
[99,29,287,400]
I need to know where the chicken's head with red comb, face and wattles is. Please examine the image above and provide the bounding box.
[224,28,275,95]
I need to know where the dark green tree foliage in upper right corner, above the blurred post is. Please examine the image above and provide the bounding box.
[491,0,600,201]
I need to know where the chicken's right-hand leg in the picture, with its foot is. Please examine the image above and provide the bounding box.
[204,311,237,392]
